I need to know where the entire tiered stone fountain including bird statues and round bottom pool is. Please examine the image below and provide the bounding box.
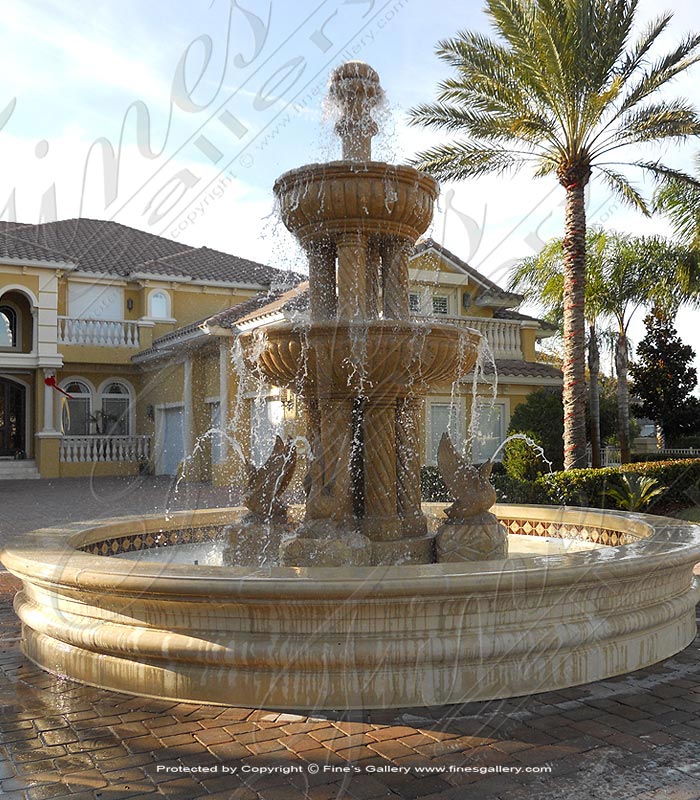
[0,63,700,709]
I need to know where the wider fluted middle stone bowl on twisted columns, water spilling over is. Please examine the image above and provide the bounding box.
[241,320,481,396]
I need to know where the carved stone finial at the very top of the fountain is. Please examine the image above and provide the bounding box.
[329,61,384,161]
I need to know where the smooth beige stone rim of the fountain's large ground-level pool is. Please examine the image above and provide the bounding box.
[0,504,700,597]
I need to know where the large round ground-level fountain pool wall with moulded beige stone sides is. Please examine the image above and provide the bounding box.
[0,504,700,709]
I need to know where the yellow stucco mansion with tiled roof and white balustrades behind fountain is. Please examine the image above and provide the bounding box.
[0,219,561,483]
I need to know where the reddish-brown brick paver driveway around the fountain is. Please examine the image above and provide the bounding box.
[0,479,700,800]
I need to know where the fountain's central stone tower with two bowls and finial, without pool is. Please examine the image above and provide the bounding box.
[243,62,482,566]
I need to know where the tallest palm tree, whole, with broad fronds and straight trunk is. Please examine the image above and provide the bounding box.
[411,0,700,468]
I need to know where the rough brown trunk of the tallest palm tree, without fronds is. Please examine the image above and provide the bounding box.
[560,178,589,469]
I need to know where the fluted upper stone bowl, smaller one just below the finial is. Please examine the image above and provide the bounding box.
[273,161,438,241]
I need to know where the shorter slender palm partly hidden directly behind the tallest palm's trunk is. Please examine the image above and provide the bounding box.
[509,228,608,467]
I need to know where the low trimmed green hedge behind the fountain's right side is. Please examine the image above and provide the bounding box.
[421,458,700,513]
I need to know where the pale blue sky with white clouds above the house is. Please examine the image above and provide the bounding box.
[0,0,700,368]
